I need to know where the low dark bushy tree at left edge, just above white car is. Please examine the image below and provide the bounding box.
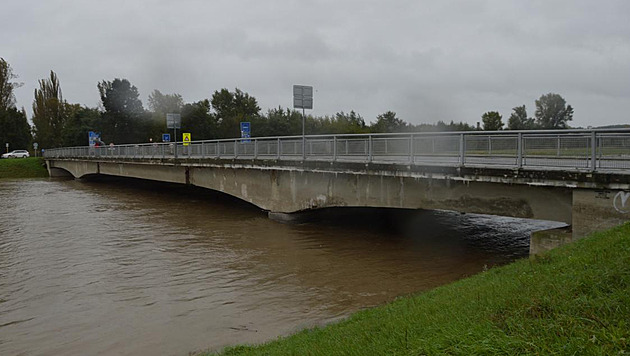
[0,107,31,149]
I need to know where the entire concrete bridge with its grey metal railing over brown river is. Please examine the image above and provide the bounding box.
[44,129,630,248]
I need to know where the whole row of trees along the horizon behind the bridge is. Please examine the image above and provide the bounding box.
[0,58,573,149]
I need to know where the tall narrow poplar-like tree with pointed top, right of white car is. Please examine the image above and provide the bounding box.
[33,70,68,148]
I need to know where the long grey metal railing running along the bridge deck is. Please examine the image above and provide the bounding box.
[44,129,630,171]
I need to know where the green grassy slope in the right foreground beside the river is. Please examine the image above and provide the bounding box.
[217,224,630,355]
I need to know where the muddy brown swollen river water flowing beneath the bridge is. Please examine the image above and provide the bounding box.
[0,180,561,355]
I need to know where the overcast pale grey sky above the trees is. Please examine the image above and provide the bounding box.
[0,0,630,127]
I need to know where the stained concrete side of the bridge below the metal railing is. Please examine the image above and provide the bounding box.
[47,159,630,245]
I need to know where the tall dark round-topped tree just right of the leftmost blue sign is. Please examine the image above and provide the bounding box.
[97,78,150,143]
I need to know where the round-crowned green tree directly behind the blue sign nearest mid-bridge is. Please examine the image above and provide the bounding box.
[210,88,260,138]
